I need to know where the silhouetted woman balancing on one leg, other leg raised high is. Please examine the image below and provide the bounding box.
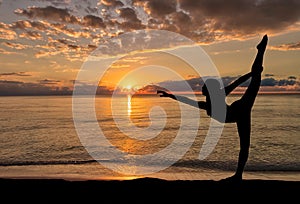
[157,35,268,181]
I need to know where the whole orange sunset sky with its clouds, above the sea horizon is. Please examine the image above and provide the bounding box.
[0,0,300,95]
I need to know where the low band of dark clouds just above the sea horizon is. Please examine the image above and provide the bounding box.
[0,73,300,96]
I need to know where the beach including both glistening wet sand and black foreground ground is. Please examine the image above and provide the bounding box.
[0,163,300,203]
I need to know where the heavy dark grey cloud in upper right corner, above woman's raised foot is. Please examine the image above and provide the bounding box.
[179,0,300,36]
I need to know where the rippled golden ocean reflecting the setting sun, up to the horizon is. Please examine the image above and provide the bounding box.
[0,94,300,180]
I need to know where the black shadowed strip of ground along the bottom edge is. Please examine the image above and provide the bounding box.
[0,178,300,203]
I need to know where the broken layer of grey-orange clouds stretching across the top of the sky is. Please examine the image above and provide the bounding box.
[8,0,300,50]
